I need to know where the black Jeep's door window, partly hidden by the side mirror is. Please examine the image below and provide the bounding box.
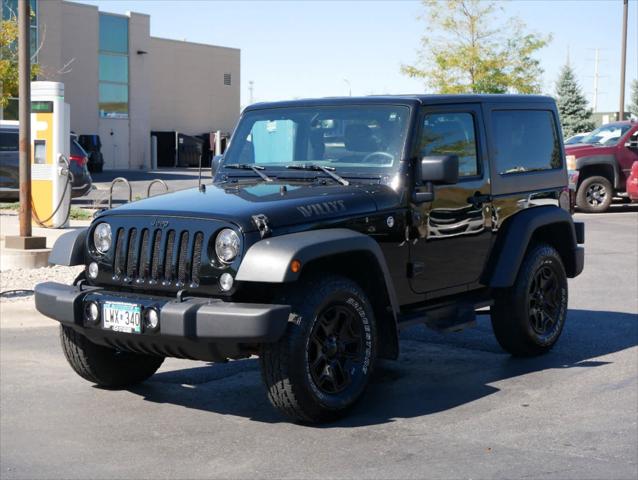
[419,113,479,177]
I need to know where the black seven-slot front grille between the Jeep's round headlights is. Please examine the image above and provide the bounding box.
[113,228,204,287]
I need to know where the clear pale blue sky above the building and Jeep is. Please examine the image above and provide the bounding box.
[81,0,638,111]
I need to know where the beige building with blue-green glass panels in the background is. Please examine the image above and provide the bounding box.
[2,0,240,169]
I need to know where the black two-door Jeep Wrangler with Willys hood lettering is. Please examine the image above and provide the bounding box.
[35,95,584,422]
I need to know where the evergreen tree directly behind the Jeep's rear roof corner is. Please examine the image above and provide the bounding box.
[556,63,595,138]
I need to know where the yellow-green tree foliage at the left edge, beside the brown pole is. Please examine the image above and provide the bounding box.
[0,10,40,108]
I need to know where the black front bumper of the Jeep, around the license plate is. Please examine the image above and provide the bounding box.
[35,282,290,361]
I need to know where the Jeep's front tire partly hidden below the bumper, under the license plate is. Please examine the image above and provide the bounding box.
[60,325,164,388]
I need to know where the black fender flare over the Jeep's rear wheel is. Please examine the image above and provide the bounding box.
[482,206,580,288]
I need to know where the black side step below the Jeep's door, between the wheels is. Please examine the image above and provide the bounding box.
[398,300,493,333]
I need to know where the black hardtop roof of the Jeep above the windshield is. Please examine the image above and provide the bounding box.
[244,94,554,112]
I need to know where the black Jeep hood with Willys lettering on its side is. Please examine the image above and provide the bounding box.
[101,182,398,231]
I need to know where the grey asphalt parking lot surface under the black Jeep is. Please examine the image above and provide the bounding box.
[0,206,638,479]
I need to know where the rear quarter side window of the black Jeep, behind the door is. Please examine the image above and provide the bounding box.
[492,110,562,175]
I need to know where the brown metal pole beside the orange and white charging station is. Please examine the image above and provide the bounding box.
[18,0,31,237]
